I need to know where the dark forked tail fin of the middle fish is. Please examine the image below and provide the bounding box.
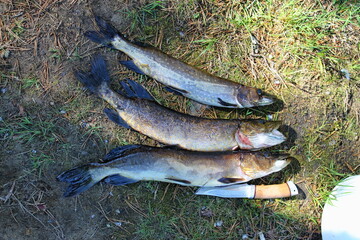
[75,55,110,95]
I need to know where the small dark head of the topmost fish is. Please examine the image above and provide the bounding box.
[236,85,274,107]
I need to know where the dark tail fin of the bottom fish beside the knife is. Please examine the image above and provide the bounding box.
[56,164,99,197]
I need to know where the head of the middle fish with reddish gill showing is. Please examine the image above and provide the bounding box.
[235,120,286,150]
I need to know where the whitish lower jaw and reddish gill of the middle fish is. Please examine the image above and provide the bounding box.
[235,129,286,150]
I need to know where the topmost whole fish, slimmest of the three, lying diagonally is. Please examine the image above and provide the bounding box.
[85,17,274,108]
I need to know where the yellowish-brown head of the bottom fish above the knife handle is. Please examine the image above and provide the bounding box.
[240,152,294,179]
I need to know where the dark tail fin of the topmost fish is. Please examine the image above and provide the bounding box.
[84,16,124,49]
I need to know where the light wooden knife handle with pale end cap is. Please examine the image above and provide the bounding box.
[254,181,299,199]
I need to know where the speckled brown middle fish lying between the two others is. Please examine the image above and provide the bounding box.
[75,56,285,152]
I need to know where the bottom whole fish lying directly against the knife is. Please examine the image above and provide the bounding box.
[57,145,292,197]
